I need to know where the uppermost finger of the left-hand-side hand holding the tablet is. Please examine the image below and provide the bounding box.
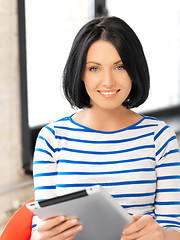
[37,215,66,232]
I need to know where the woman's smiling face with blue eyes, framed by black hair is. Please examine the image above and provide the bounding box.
[83,40,132,110]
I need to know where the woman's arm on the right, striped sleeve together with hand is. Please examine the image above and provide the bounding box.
[122,125,180,240]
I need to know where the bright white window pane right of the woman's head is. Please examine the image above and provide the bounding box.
[106,0,180,112]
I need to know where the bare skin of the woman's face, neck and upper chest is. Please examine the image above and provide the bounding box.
[73,40,142,131]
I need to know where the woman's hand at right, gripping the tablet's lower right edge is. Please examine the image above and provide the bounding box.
[121,214,165,240]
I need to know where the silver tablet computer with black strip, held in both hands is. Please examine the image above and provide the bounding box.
[26,186,133,240]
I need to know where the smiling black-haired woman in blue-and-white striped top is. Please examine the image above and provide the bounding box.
[32,17,180,240]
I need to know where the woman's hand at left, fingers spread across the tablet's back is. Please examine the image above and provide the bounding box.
[33,216,82,240]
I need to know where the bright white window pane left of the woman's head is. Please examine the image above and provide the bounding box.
[25,0,91,127]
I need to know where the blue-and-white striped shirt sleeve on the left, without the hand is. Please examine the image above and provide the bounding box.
[32,123,57,236]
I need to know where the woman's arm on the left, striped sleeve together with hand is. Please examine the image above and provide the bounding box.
[31,125,82,240]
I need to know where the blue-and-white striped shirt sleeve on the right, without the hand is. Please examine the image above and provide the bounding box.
[154,124,180,231]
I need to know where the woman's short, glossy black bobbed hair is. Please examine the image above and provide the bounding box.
[63,17,150,108]
